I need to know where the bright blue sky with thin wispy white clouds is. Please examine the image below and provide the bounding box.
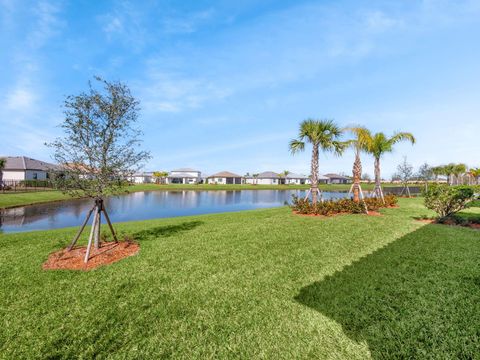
[0,0,480,177]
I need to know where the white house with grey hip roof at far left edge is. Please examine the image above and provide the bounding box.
[0,156,58,181]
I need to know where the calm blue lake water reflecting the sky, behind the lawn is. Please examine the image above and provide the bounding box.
[0,190,347,233]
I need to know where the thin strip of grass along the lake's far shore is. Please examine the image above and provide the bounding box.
[0,184,404,209]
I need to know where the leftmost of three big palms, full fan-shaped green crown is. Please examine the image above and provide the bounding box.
[290,119,348,204]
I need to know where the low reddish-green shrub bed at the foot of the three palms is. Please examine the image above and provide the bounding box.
[290,195,398,216]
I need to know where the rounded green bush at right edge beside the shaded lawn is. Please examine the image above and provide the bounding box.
[423,185,474,219]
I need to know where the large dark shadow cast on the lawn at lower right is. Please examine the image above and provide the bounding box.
[296,225,480,359]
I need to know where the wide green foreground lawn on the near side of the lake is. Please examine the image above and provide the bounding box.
[0,199,480,359]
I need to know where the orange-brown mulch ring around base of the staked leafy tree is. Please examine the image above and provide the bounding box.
[43,241,140,271]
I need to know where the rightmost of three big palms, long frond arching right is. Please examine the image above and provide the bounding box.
[366,132,415,199]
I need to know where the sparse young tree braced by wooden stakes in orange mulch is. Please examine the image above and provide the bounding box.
[48,77,150,262]
